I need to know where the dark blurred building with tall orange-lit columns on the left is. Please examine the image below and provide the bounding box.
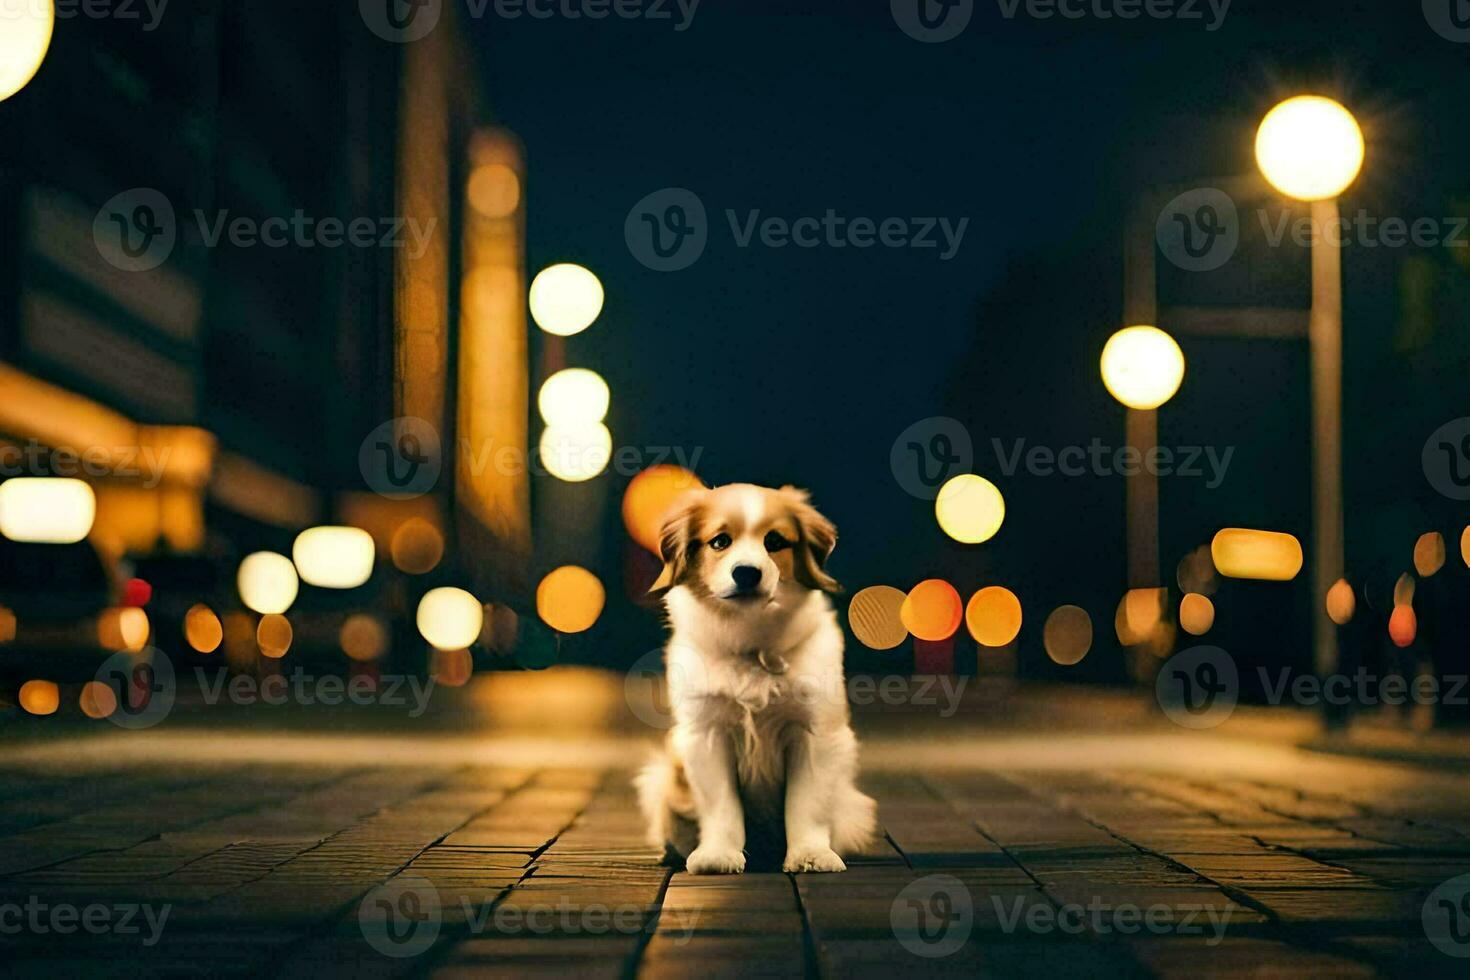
[0,0,531,598]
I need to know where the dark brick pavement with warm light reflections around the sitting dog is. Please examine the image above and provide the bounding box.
[0,687,1470,980]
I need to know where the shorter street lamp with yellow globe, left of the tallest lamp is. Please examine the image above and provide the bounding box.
[1100,325,1185,589]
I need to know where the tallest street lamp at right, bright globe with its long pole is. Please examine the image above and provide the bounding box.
[1255,96,1364,687]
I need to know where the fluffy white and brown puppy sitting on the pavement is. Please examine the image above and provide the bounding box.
[635,483,878,874]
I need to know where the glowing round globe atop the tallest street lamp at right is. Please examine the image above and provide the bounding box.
[1255,96,1364,201]
